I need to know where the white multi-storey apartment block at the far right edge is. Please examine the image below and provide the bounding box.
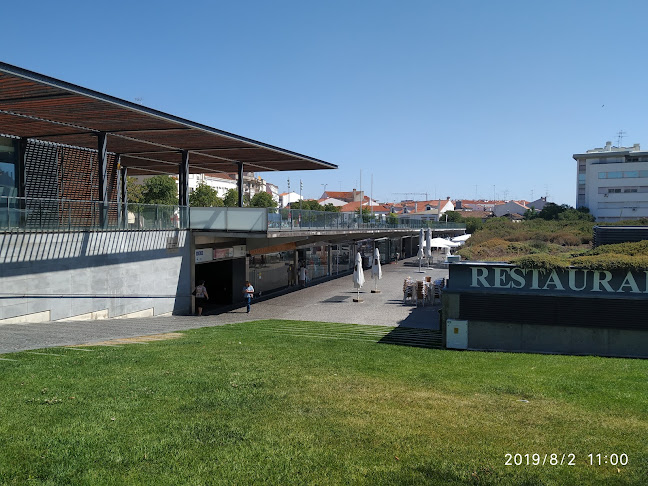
[573,142,648,221]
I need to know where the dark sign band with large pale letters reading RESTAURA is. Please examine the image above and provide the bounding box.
[448,263,648,296]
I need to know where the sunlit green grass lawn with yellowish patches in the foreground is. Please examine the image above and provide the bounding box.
[0,321,648,485]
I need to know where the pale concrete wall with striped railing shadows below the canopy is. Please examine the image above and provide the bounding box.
[0,231,192,323]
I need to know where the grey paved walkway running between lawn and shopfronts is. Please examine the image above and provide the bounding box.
[0,259,448,354]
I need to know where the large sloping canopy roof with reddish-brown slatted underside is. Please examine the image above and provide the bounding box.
[0,62,337,175]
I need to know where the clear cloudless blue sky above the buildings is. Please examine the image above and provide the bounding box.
[0,0,648,205]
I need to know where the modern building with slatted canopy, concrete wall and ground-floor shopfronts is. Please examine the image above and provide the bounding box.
[0,62,465,324]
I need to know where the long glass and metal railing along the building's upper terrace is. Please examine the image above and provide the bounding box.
[0,196,465,232]
